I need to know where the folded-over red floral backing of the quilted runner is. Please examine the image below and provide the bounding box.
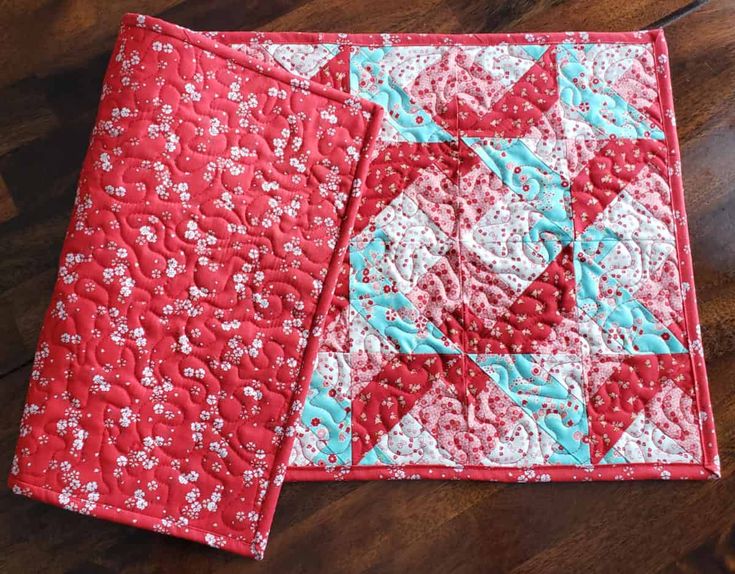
[10,16,381,558]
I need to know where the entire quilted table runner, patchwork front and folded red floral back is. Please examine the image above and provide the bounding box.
[10,15,719,557]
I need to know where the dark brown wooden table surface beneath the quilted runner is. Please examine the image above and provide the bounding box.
[0,0,735,573]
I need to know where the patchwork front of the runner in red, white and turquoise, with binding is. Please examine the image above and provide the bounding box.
[220,31,718,481]
